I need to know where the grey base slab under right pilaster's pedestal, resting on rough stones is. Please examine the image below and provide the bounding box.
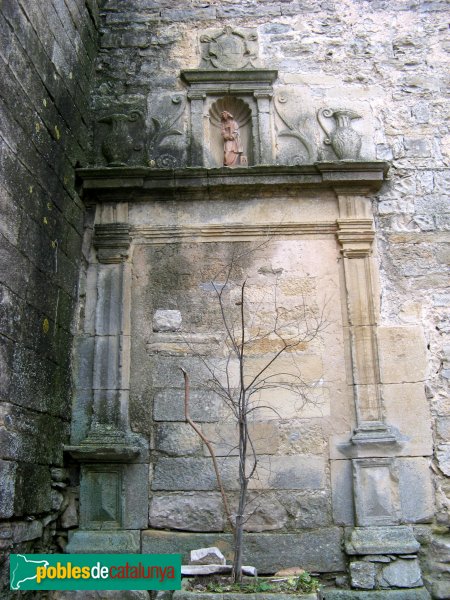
[345,525,420,555]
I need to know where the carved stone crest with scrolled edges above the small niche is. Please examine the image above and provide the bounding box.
[200,27,258,70]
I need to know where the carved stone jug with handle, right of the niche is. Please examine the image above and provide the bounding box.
[317,108,361,160]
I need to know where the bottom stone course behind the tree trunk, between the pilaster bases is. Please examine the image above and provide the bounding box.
[142,527,344,574]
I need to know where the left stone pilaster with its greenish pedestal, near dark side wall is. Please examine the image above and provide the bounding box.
[66,203,148,552]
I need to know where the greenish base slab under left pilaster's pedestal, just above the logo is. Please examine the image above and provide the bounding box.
[66,529,141,554]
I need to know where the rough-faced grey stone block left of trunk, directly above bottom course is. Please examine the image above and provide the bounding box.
[150,493,224,532]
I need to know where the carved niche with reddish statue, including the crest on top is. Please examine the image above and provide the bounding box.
[181,27,278,167]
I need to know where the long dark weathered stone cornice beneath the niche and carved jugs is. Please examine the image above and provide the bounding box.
[77,161,389,202]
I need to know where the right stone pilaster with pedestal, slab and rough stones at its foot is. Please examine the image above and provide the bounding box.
[337,193,423,593]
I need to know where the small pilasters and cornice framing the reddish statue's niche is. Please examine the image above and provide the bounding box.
[181,69,278,167]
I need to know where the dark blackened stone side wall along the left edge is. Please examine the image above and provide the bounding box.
[0,0,97,598]
